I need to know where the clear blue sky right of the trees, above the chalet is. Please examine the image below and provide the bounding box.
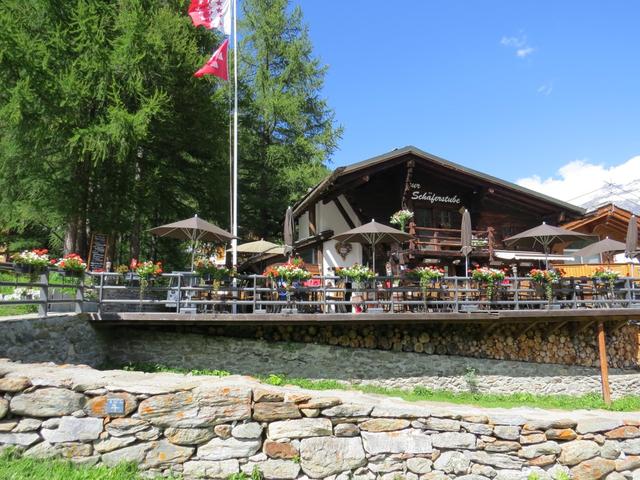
[294,0,640,200]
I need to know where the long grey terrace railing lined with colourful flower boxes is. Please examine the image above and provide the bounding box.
[0,265,640,316]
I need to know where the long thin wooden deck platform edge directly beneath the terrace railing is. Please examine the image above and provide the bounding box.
[91,308,640,326]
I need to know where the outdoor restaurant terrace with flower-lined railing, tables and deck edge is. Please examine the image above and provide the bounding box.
[5,265,640,324]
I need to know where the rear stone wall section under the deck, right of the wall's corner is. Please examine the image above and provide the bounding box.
[108,327,640,397]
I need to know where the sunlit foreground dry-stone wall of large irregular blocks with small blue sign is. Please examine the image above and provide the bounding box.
[0,361,640,480]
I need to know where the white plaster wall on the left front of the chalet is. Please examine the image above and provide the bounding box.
[316,196,362,275]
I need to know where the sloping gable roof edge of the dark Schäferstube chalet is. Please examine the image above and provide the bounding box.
[293,145,585,217]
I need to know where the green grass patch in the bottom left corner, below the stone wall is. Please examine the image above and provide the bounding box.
[0,451,160,480]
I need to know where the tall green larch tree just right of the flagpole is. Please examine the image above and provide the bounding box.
[238,0,341,238]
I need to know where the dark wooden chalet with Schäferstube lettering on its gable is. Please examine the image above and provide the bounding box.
[294,146,584,275]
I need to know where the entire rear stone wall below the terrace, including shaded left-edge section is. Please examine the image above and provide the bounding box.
[0,315,640,397]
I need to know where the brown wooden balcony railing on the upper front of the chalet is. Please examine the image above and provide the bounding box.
[409,223,496,257]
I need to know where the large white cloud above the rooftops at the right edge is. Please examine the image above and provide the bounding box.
[516,155,640,210]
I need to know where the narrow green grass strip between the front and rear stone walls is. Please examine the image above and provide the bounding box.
[117,364,640,412]
